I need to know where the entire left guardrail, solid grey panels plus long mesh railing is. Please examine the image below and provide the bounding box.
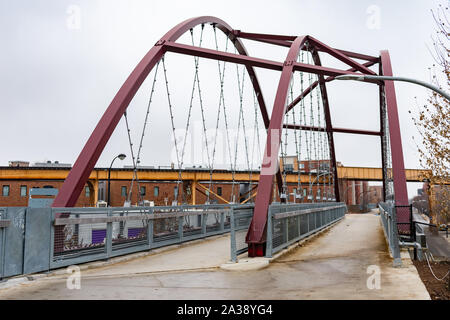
[0,205,241,279]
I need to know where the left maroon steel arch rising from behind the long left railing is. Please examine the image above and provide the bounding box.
[53,16,281,207]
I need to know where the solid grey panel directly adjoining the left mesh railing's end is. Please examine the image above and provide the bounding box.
[23,208,52,274]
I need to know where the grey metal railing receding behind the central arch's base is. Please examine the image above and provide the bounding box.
[266,202,347,258]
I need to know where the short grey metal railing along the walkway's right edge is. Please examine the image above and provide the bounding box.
[379,202,402,267]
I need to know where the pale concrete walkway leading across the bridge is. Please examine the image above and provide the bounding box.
[0,214,429,300]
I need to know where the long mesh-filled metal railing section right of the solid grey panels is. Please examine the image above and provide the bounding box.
[50,205,230,268]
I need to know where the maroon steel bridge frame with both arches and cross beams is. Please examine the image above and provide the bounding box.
[53,16,409,256]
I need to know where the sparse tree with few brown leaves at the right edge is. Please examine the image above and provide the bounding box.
[413,1,450,223]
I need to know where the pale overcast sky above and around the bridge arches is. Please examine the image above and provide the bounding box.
[0,0,441,198]
